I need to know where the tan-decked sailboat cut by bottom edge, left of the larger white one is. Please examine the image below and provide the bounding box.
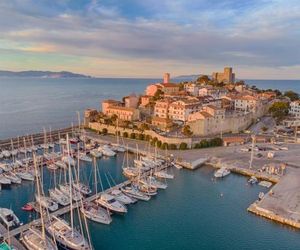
[20,228,58,250]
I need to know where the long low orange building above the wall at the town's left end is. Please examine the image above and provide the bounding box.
[105,106,140,121]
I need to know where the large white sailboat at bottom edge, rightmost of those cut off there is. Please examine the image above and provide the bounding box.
[46,216,92,250]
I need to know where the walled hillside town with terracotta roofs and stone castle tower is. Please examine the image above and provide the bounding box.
[85,67,300,148]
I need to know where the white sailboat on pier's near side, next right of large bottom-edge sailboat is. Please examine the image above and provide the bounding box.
[80,202,112,225]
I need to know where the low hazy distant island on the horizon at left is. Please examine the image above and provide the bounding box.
[0,70,92,78]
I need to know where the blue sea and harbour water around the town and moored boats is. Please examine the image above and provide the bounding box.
[0,78,300,250]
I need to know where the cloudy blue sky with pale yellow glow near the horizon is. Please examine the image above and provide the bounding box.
[0,0,300,79]
